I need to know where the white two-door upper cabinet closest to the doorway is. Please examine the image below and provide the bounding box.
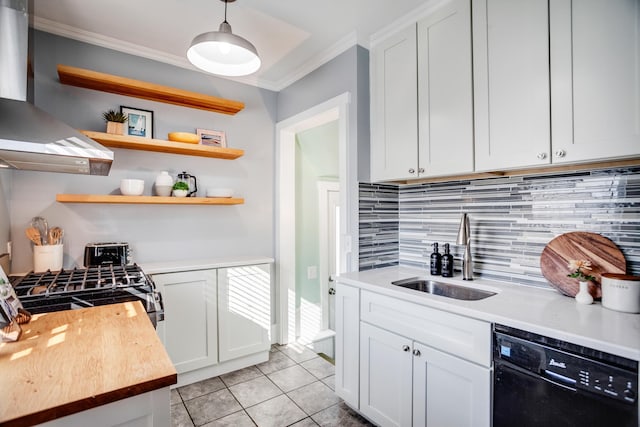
[371,0,473,181]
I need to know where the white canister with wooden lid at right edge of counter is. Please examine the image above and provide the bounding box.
[601,273,640,313]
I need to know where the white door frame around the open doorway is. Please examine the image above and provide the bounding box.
[274,92,358,344]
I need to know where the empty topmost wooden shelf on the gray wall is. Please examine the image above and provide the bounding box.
[58,64,244,115]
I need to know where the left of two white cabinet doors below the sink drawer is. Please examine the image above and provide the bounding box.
[360,322,410,427]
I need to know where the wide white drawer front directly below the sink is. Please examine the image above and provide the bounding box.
[360,291,491,366]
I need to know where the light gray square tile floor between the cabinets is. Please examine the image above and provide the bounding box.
[171,345,373,427]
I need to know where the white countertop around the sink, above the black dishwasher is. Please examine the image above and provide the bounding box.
[338,267,640,361]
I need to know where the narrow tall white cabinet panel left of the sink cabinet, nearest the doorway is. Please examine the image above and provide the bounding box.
[335,282,360,409]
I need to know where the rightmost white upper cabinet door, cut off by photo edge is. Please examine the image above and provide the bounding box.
[550,0,640,163]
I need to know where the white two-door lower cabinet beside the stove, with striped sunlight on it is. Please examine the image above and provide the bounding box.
[152,264,272,386]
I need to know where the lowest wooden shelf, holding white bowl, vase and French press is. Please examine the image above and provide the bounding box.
[56,194,244,205]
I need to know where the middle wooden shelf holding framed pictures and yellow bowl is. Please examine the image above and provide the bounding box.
[80,130,244,160]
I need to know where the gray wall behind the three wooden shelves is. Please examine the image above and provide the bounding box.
[7,31,276,272]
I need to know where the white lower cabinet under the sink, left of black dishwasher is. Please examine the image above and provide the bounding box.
[336,283,491,427]
